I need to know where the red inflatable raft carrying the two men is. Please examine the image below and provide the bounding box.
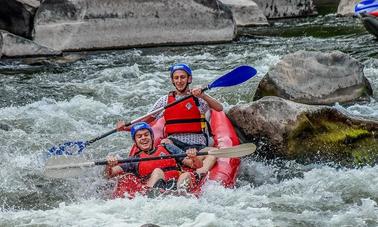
[113,111,240,198]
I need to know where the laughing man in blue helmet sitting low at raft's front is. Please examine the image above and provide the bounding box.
[105,122,202,189]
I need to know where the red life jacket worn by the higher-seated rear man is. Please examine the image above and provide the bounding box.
[164,92,206,135]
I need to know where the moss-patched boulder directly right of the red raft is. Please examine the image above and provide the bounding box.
[228,96,378,166]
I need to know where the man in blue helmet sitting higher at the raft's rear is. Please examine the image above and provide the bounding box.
[117,63,223,175]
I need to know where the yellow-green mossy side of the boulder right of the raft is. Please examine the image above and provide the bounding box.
[287,111,378,166]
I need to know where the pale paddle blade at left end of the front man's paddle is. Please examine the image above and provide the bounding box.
[44,155,95,178]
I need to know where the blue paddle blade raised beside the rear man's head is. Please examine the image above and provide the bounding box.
[208,65,257,89]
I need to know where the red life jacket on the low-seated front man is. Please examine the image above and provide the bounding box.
[137,146,180,180]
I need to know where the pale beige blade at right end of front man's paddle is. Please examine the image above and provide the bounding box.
[207,143,256,158]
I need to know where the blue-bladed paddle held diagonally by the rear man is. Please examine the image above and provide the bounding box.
[49,65,257,155]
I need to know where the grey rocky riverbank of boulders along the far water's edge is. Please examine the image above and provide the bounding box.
[0,0,351,57]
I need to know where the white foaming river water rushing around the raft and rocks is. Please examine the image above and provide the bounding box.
[0,15,378,227]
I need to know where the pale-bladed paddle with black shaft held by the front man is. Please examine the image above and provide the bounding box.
[44,143,256,178]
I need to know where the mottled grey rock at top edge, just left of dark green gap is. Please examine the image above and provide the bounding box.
[254,0,317,19]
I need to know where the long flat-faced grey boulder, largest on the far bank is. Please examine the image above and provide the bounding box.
[34,0,235,50]
